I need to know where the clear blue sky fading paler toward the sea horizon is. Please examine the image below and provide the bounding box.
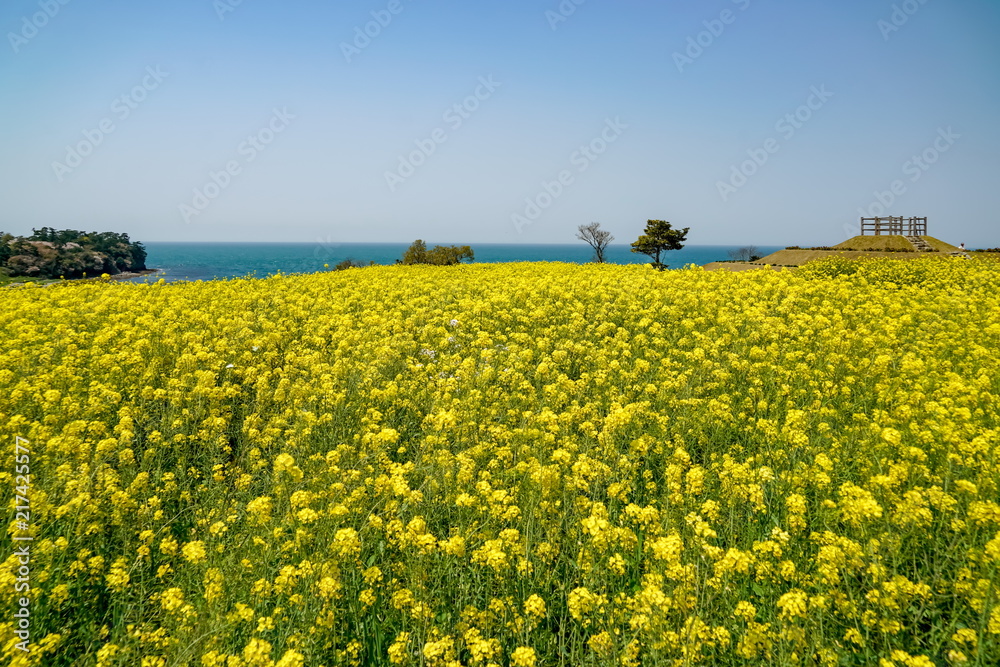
[0,0,1000,246]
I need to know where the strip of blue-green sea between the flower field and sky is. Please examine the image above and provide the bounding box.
[134,242,780,282]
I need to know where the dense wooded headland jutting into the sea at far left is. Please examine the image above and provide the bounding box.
[0,227,146,278]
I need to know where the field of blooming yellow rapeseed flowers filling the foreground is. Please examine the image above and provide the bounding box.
[0,259,1000,667]
